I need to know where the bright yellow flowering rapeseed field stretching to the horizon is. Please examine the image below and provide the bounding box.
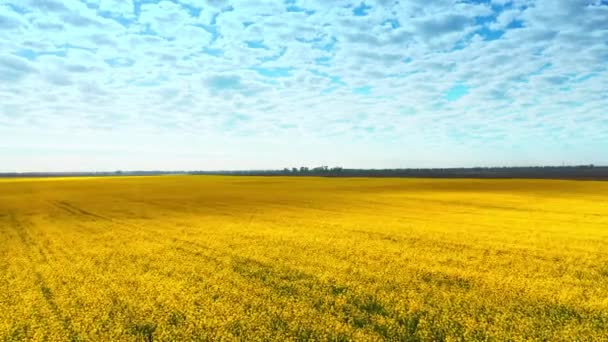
[0,176,608,341]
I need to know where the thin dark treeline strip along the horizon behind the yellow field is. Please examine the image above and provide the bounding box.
[0,165,608,180]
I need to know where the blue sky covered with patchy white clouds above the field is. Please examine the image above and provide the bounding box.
[0,0,608,172]
